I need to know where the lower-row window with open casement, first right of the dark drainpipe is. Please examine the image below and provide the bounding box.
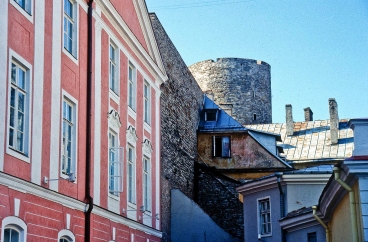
[109,131,122,196]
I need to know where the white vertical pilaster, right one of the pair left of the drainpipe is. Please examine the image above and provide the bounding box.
[49,1,63,191]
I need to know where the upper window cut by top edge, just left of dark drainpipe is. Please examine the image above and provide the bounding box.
[64,0,77,57]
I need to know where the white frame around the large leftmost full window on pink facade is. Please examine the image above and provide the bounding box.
[6,49,32,163]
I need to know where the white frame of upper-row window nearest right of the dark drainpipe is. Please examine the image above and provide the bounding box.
[109,39,120,96]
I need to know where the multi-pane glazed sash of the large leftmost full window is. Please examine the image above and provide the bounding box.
[8,60,30,156]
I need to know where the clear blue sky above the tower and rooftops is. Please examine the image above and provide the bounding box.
[146,0,368,123]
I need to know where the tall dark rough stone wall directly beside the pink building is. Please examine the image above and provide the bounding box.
[150,13,203,241]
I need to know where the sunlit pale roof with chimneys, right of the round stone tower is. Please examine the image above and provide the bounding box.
[245,119,354,163]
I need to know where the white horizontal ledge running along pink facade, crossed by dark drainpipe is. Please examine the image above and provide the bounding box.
[0,172,162,238]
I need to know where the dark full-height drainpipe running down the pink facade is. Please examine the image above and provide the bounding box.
[84,0,93,242]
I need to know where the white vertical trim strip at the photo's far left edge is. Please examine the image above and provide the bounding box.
[0,1,8,171]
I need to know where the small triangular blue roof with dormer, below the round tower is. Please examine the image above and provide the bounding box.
[198,96,247,132]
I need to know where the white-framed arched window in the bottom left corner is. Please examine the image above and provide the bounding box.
[1,216,27,242]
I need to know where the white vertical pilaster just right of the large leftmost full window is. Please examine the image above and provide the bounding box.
[31,0,45,185]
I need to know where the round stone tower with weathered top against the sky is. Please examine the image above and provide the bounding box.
[189,58,272,124]
